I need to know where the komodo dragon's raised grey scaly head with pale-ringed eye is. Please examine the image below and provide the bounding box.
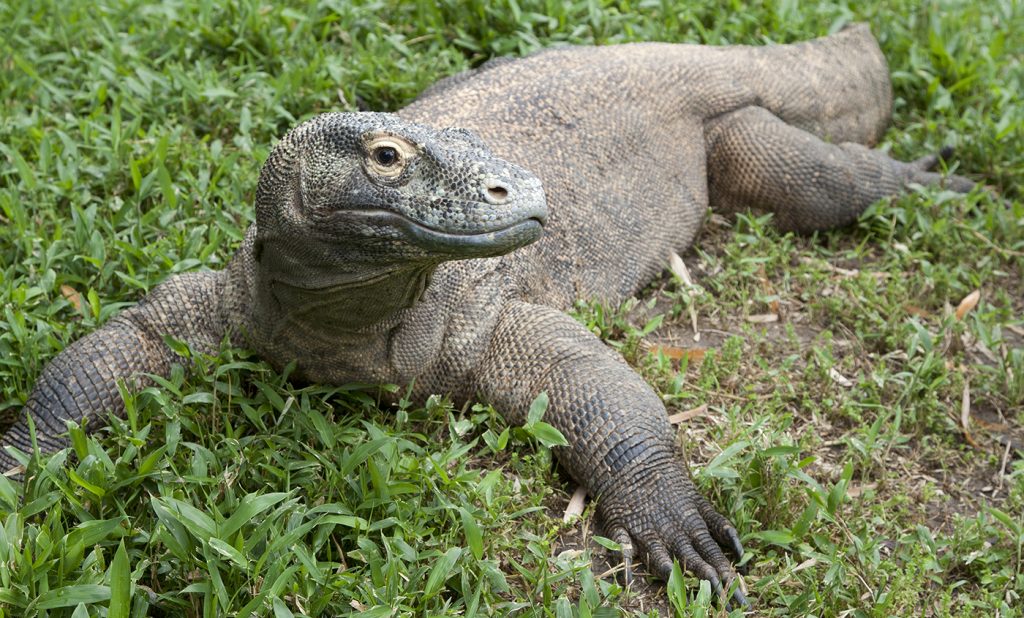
[255,113,547,276]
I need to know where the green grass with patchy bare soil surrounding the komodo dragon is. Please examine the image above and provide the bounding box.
[0,0,1024,618]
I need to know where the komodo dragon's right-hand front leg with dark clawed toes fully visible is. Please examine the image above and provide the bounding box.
[476,302,746,605]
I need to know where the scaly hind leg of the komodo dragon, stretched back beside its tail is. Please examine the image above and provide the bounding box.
[705,106,975,232]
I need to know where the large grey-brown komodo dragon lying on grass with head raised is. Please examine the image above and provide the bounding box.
[0,26,973,603]
